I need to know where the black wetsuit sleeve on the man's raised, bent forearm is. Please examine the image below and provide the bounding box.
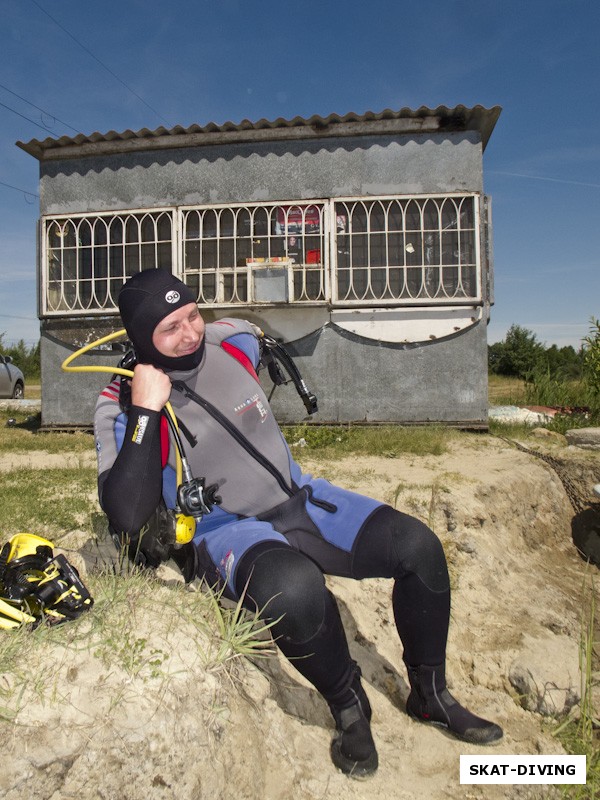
[98,406,162,535]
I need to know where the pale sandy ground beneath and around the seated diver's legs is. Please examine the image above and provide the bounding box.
[0,436,600,800]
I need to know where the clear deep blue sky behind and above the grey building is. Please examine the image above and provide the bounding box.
[0,0,600,348]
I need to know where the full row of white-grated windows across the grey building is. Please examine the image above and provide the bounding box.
[42,194,481,315]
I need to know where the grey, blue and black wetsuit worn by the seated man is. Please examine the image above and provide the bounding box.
[95,312,450,707]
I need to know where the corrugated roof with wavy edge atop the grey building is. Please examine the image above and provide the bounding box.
[17,105,502,161]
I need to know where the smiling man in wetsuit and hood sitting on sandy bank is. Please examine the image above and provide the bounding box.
[95,269,502,776]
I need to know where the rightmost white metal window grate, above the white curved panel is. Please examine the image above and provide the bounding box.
[333,195,480,305]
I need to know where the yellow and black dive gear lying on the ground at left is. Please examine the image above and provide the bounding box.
[0,533,94,629]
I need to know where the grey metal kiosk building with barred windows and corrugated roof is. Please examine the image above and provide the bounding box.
[17,106,500,428]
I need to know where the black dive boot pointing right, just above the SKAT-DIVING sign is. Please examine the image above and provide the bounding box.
[406,664,503,744]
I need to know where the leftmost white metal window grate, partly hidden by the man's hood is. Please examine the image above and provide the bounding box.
[42,210,175,314]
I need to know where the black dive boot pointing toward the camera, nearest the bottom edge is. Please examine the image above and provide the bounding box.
[329,671,379,778]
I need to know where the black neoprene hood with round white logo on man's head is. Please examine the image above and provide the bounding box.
[118,269,203,370]
